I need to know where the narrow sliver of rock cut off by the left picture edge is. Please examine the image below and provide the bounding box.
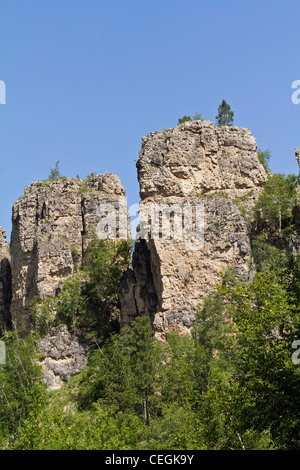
[0,227,11,326]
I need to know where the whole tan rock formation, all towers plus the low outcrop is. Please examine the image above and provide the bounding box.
[0,120,274,388]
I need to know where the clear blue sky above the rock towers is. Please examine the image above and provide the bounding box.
[0,0,300,233]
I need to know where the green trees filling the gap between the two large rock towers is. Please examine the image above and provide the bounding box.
[31,237,131,342]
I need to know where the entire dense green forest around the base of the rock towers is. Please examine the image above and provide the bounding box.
[0,162,300,450]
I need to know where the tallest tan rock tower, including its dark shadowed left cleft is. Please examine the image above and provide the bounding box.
[122,121,267,335]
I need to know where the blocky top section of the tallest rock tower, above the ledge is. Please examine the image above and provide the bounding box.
[137,121,266,200]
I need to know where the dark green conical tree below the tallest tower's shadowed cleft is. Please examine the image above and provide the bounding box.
[76,317,162,425]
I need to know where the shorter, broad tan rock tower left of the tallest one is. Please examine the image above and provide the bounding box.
[11,173,130,328]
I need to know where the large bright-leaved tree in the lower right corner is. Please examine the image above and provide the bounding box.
[219,273,300,449]
